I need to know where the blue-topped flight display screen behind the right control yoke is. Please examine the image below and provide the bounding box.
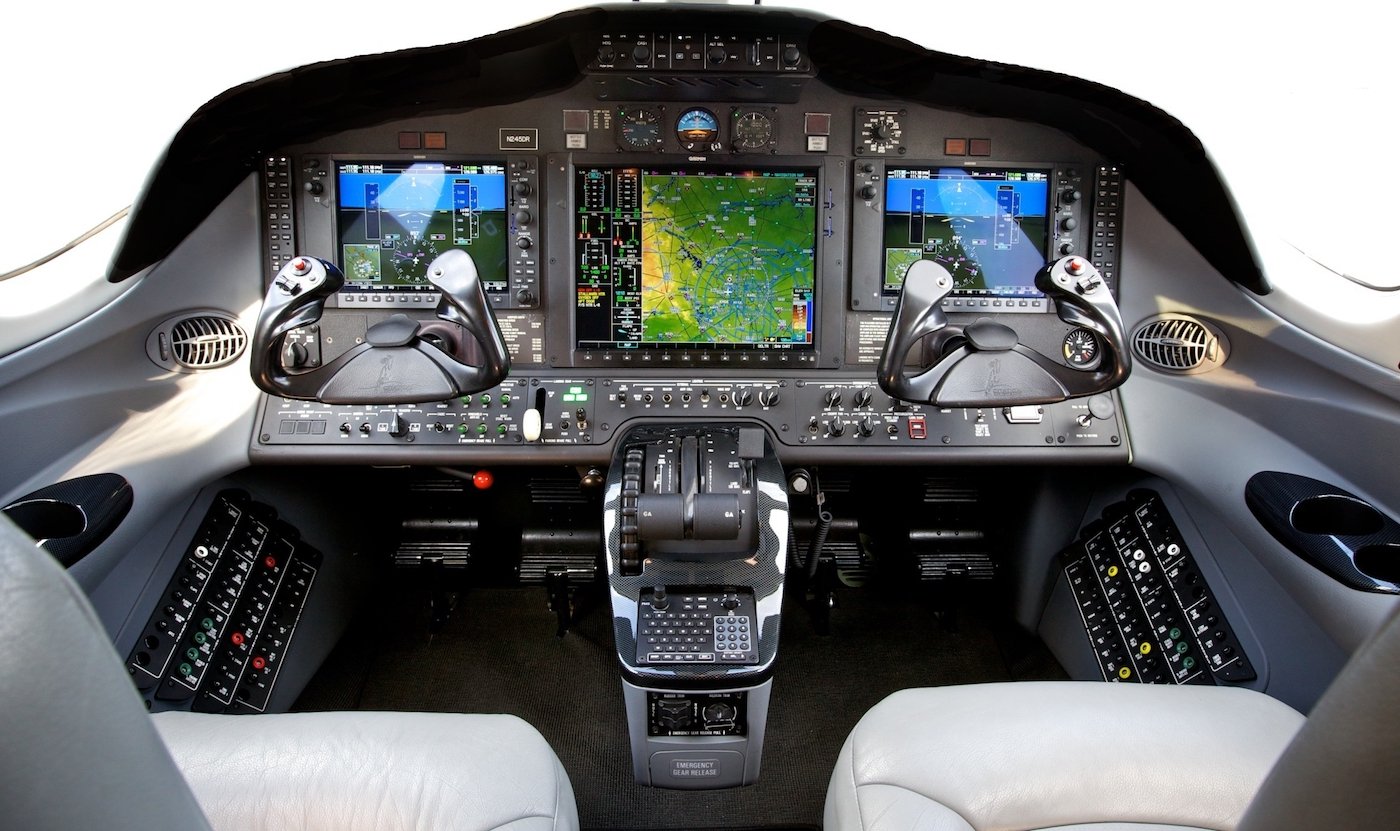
[883,166,1050,298]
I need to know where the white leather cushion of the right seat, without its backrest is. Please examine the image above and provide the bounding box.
[825,681,1303,831]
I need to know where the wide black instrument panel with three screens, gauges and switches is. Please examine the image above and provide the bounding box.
[252,24,1128,463]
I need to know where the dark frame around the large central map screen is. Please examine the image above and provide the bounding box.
[571,157,840,365]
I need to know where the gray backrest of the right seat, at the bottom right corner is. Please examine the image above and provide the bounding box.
[1240,604,1400,831]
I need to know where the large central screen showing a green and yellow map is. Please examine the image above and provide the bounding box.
[574,166,818,350]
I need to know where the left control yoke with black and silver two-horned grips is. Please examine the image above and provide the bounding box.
[252,249,510,404]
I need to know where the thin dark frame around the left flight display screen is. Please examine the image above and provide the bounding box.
[326,154,514,293]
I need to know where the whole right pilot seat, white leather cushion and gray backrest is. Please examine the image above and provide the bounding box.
[826,604,1400,831]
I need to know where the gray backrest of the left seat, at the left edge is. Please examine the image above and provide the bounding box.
[0,516,209,831]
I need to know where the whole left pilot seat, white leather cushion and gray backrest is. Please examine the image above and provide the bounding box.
[0,516,578,831]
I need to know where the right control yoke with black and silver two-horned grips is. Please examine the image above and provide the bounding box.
[878,256,1133,407]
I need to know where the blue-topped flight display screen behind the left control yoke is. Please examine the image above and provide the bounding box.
[336,161,508,292]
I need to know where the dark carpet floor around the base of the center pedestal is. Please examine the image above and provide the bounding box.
[297,579,1065,828]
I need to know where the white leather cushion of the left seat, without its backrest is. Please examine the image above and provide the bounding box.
[151,712,578,831]
